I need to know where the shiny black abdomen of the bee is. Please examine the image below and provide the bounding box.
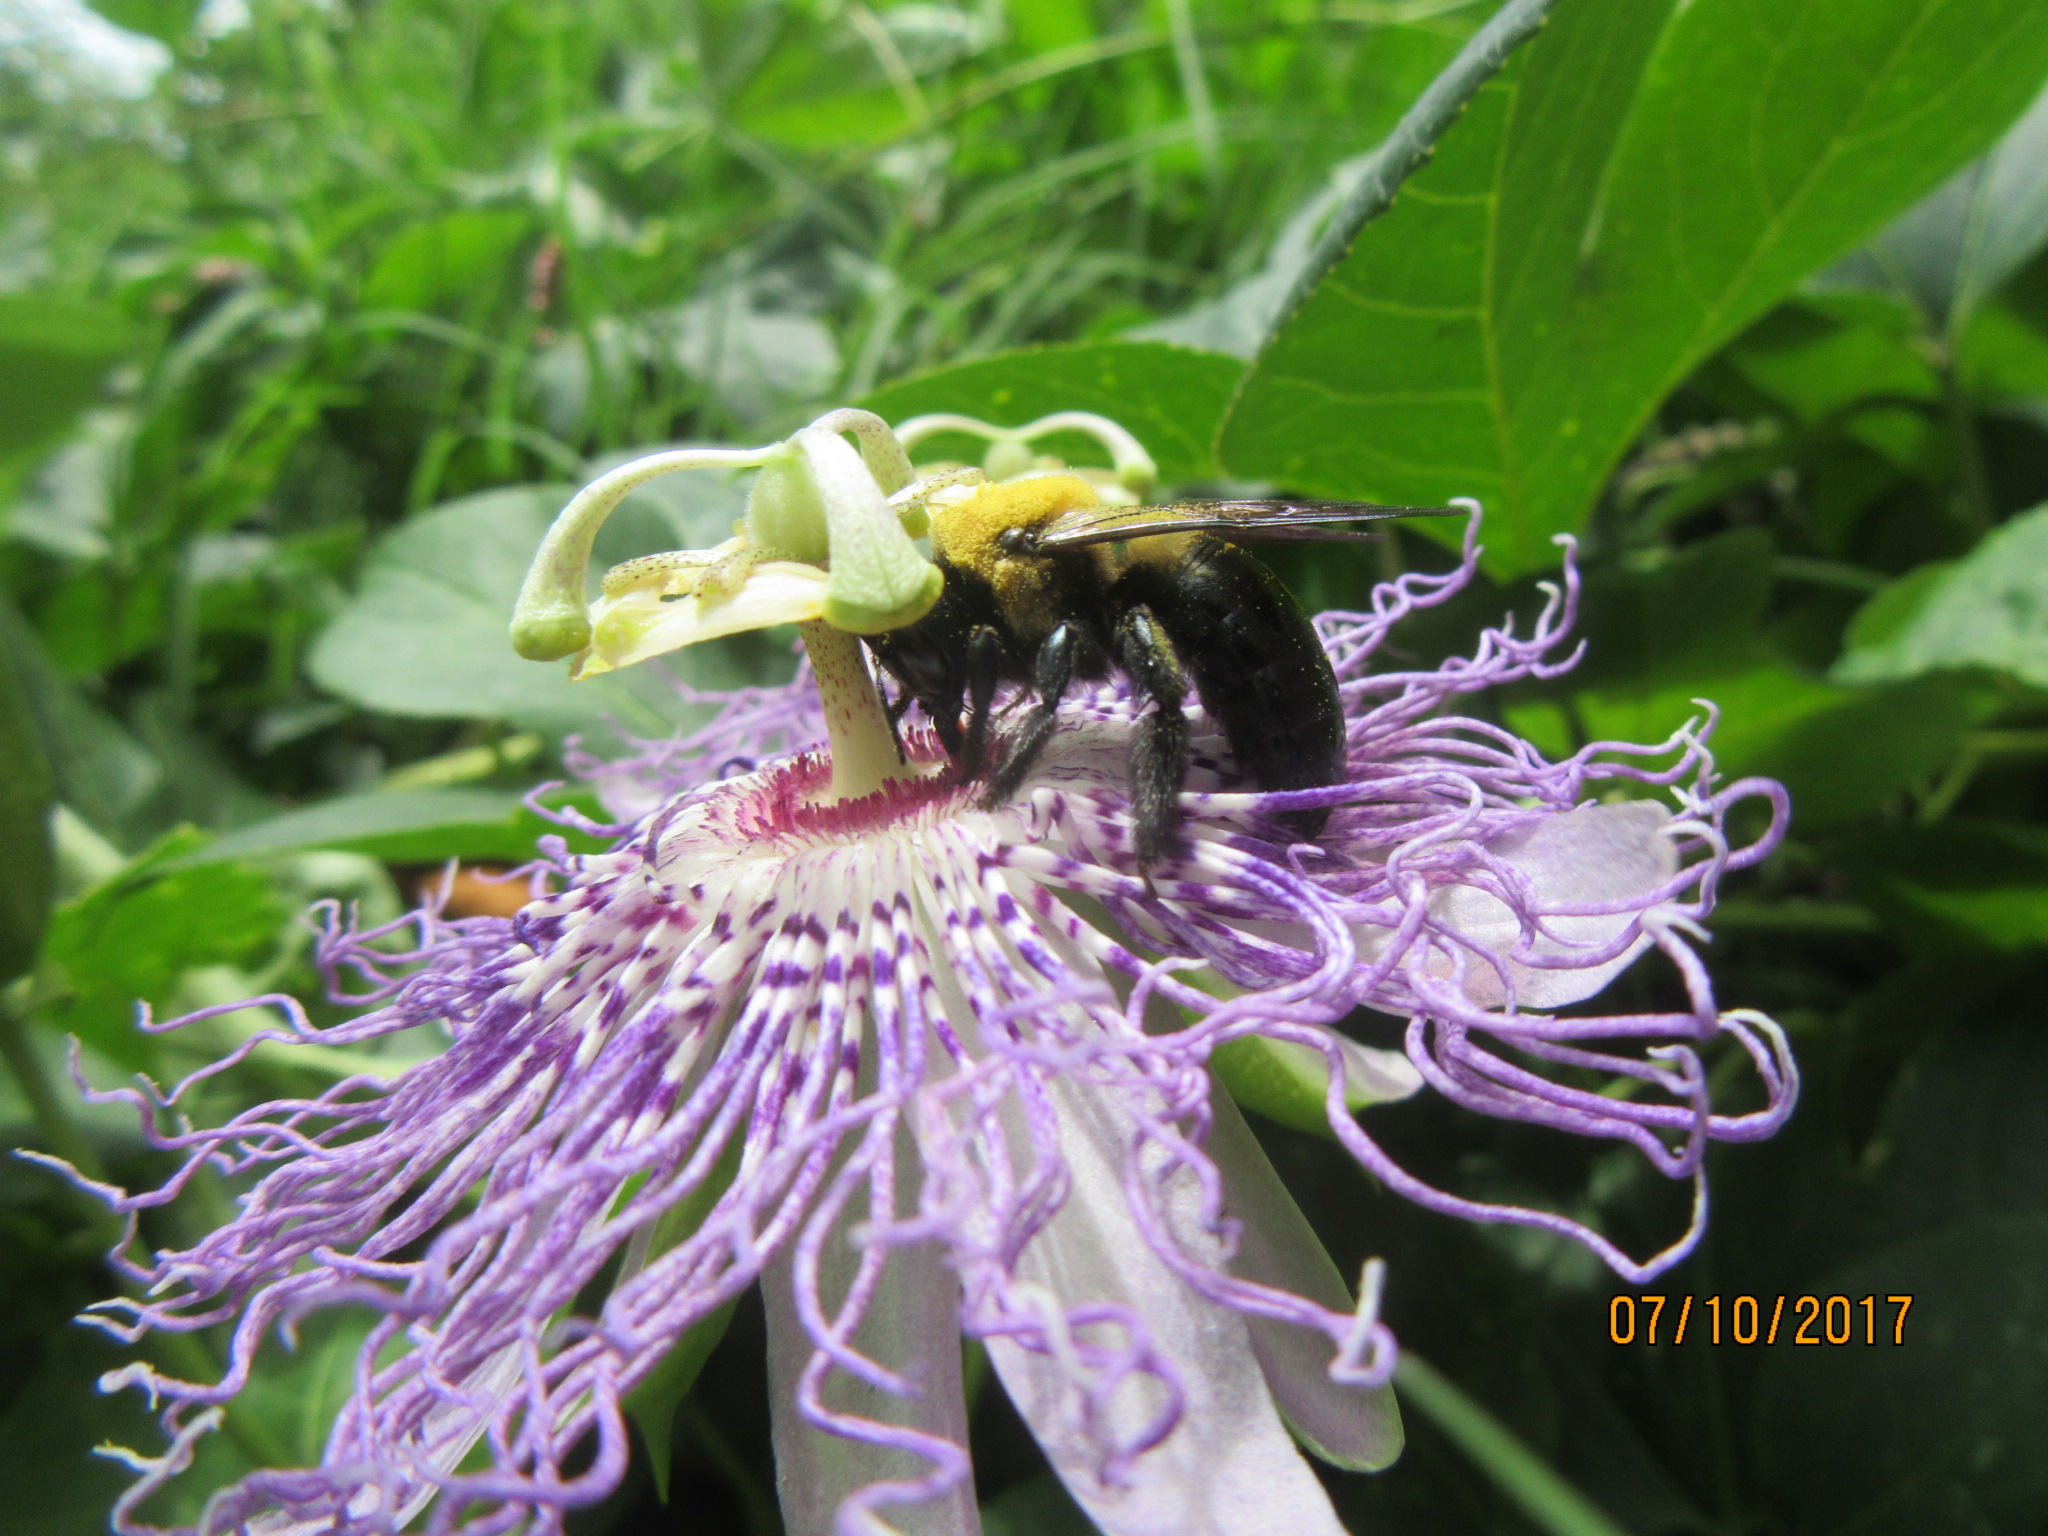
[1112,539,1343,838]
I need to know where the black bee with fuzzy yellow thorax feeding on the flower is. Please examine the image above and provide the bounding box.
[866,475,1456,870]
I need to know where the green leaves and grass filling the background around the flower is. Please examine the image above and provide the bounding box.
[0,0,2048,1536]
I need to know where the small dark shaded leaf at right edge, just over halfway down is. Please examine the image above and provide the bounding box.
[1843,819,2048,952]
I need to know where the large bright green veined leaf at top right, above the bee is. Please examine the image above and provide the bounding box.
[1221,0,2048,571]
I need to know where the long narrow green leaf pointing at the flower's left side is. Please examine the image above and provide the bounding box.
[176,788,602,868]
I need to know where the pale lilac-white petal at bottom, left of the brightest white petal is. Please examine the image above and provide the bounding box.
[762,1171,981,1536]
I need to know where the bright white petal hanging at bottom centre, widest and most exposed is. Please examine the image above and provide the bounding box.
[989,1081,1343,1536]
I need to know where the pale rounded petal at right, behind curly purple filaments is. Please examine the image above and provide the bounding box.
[1430,801,1677,1008]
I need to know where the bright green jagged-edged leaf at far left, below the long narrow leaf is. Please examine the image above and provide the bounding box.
[41,831,289,1071]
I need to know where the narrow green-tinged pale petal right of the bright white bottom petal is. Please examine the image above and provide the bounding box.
[1208,1089,1405,1473]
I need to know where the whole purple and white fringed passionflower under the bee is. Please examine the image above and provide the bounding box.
[59,412,1796,1536]
